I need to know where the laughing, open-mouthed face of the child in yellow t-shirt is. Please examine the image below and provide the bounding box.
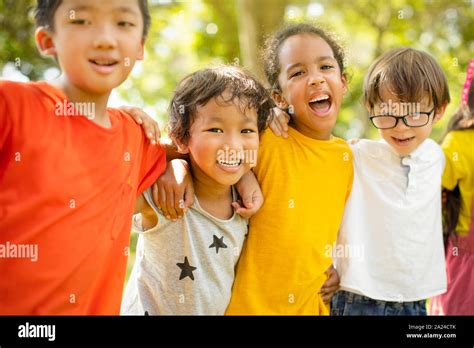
[273,34,347,140]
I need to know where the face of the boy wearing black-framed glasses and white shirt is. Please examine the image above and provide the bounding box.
[369,89,446,156]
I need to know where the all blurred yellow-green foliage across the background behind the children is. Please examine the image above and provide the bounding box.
[0,0,474,140]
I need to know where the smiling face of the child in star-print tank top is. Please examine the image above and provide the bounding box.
[175,97,259,186]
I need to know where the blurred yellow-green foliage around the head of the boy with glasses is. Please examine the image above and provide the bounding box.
[274,0,474,140]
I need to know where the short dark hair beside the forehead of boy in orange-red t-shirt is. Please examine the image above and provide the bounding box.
[35,0,151,38]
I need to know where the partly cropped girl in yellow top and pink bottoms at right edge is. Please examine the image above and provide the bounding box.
[430,59,474,315]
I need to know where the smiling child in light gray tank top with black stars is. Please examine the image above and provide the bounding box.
[121,66,273,315]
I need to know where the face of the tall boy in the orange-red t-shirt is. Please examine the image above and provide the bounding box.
[36,0,143,95]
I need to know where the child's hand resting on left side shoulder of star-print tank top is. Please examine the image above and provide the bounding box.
[152,159,194,221]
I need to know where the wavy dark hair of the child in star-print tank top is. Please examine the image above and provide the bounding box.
[168,65,274,144]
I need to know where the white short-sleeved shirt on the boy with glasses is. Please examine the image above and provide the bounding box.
[333,139,446,302]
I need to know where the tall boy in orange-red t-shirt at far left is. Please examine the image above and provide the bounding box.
[0,0,166,315]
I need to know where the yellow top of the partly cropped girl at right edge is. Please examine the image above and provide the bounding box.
[441,129,474,235]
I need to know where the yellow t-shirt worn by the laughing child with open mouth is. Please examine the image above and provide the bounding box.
[226,128,353,315]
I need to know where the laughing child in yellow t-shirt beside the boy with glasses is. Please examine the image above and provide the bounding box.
[226,24,353,315]
